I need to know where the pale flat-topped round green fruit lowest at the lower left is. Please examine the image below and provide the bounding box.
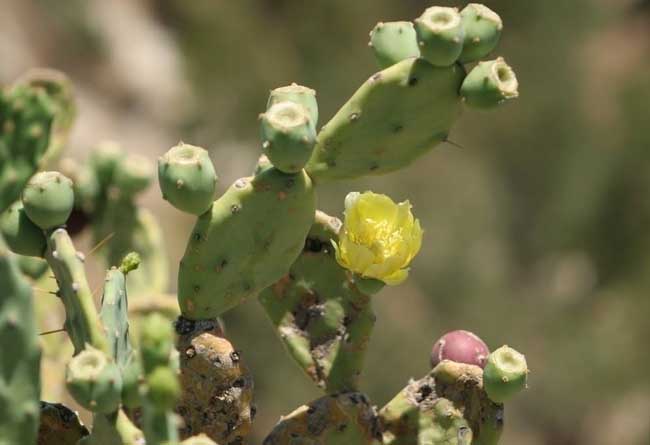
[65,346,122,414]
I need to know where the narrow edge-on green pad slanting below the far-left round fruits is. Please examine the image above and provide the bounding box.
[45,229,109,353]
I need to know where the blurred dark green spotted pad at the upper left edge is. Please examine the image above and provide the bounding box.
[0,85,56,212]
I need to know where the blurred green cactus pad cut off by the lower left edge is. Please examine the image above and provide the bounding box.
[0,236,41,445]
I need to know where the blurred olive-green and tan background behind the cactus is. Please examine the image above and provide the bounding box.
[0,0,650,445]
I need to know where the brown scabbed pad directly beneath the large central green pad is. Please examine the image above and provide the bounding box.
[176,316,255,445]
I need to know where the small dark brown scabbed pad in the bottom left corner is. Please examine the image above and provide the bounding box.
[37,401,88,445]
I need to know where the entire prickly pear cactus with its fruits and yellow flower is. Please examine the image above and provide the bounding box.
[0,4,528,445]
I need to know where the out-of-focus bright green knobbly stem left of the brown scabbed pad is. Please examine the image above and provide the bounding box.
[140,314,180,445]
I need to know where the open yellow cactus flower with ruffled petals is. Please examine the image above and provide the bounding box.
[334,192,422,285]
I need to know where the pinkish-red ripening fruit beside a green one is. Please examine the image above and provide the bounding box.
[431,330,490,368]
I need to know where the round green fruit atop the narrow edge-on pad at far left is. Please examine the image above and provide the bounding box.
[22,172,74,230]
